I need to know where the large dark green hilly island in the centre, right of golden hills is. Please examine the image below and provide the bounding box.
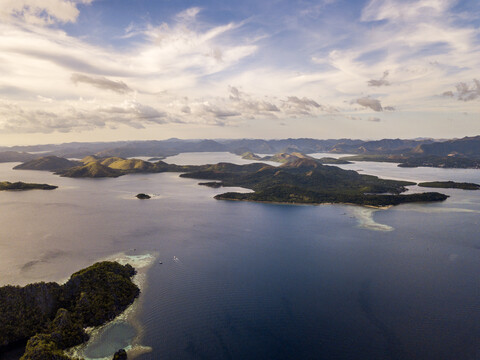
[180,158,448,207]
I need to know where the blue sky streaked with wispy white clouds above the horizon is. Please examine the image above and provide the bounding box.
[0,0,480,146]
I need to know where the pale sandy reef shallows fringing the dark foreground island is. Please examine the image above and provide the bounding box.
[65,253,158,360]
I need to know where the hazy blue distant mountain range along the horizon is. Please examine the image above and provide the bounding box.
[0,136,480,168]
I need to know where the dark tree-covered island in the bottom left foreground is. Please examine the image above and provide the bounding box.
[0,261,140,360]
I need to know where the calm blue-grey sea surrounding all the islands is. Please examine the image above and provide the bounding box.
[0,153,480,360]
